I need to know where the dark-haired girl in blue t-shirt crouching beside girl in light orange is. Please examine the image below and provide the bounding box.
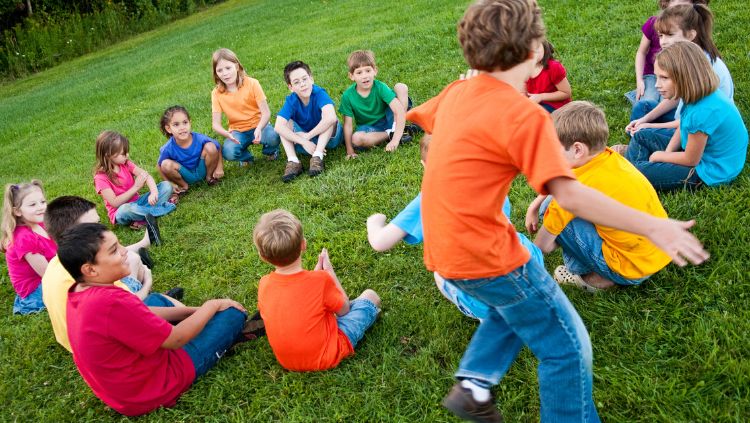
[157,106,224,197]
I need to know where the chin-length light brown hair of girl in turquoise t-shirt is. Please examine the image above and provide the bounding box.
[656,41,719,104]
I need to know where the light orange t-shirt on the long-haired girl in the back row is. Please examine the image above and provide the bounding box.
[211,75,266,132]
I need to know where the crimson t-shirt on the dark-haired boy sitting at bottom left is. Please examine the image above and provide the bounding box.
[67,285,195,416]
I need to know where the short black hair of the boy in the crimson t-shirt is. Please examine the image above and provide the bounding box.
[57,223,109,282]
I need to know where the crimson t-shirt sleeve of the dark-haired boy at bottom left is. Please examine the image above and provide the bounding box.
[107,290,172,355]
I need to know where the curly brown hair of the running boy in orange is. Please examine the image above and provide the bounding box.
[458,0,544,72]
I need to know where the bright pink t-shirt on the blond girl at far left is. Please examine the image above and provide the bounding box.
[5,223,57,298]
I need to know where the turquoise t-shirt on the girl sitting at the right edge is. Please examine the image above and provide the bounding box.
[680,90,748,186]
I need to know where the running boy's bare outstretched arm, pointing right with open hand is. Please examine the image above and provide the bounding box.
[546,177,709,266]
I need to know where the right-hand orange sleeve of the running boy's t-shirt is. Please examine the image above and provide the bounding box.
[507,107,575,194]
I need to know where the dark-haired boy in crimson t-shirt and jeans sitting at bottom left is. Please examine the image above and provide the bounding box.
[57,223,256,416]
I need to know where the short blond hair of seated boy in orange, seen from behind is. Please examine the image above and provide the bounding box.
[253,209,305,266]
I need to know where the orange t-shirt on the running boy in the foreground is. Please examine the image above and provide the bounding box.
[406,74,575,279]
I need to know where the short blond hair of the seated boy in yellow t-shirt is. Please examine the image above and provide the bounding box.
[552,101,609,153]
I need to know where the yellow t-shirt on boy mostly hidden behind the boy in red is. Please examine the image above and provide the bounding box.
[42,256,130,353]
